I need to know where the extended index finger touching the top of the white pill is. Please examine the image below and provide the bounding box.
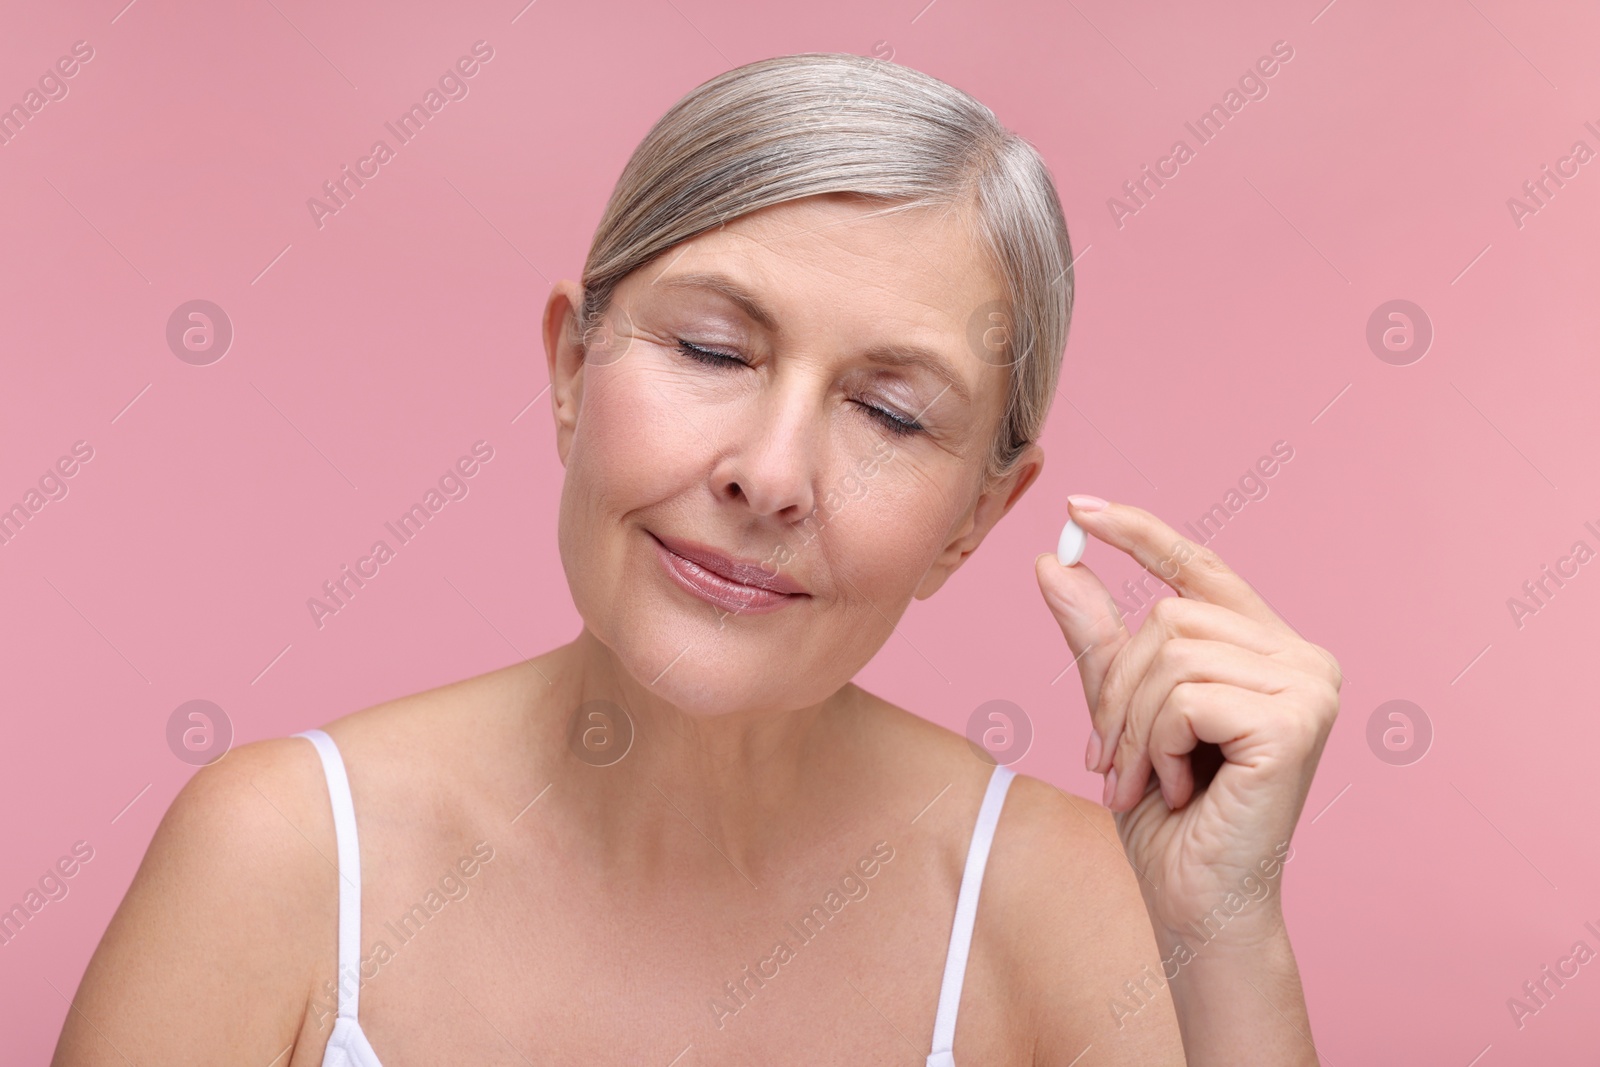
[1069,504,1298,637]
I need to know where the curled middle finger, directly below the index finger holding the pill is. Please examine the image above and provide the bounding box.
[1090,597,1298,774]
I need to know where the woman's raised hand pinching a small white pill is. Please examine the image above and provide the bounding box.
[1034,498,1342,955]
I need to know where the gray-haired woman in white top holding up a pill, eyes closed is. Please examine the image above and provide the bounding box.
[56,54,1339,1067]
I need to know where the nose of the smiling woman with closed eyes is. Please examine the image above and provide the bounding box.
[712,381,824,523]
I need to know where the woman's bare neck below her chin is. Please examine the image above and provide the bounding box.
[541,627,858,883]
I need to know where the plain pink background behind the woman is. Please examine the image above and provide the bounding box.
[0,0,1600,1065]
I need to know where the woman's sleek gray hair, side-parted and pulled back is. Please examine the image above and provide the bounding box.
[579,53,1072,482]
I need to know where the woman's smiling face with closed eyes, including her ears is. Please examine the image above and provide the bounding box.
[544,195,1043,715]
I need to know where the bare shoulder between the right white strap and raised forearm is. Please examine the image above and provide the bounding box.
[984,774,1184,1065]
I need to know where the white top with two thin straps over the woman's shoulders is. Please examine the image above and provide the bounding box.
[294,729,1016,1067]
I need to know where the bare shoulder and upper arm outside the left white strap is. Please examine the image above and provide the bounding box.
[53,737,336,1067]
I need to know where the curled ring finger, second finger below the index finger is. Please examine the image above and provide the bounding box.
[1106,637,1294,811]
